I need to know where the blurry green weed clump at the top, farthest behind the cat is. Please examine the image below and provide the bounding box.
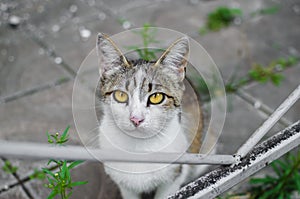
[199,6,242,34]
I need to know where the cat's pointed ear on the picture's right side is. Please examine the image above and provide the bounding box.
[155,36,189,81]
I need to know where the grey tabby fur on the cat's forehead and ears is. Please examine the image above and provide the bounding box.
[97,34,188,107]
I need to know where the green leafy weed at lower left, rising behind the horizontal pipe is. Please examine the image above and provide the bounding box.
[42,126,87,199]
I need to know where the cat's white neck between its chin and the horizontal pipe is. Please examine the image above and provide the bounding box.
[99,117,188,152]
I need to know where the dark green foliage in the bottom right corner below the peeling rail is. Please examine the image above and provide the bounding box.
[250,151,300,199]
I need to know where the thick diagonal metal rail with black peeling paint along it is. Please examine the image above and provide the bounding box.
[169,121,300,199]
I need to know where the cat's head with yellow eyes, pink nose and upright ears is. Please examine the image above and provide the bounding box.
[97,34,189,138]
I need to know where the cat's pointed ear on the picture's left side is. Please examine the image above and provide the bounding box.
[96,33,130,76]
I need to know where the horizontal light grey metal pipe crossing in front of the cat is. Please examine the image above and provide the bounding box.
[0,141,236,165]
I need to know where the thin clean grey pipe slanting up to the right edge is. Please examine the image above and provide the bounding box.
[236,84,300,157]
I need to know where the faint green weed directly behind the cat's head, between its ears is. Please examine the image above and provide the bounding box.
[127,23,163,61]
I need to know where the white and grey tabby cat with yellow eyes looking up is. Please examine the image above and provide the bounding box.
[96,33,205,199]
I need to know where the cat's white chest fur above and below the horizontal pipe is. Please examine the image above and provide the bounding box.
[100,117,188,192]
